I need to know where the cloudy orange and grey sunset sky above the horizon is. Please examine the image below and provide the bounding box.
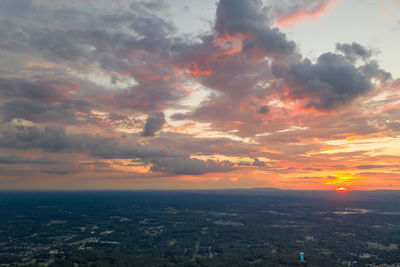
[0,0,400,190]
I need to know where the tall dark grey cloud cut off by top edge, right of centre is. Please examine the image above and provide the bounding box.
[214,0,296,58]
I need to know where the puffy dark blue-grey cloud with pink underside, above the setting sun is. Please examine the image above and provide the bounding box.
[273,53,372,110]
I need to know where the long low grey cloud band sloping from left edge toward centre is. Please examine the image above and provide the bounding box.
[0,126,233,174]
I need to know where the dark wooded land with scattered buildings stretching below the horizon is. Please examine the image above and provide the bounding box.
[0,189,400,266]
